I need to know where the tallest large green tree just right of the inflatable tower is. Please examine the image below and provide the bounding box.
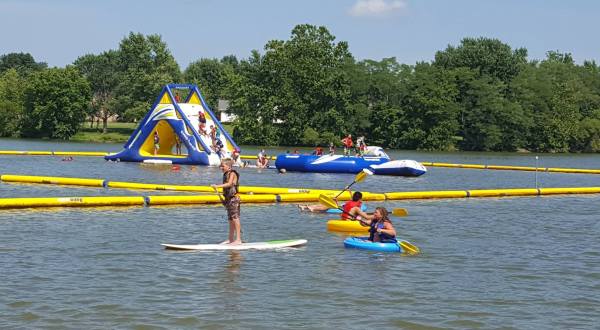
[228,25,353,145]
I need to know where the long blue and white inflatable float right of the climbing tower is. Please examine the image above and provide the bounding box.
[275,146,427,176]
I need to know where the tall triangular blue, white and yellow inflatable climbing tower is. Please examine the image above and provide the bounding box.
[104,84,239,165]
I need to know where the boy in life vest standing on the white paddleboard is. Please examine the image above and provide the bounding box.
[211,158,242,244]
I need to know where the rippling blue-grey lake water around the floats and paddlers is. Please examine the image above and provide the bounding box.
[0,139,600,329]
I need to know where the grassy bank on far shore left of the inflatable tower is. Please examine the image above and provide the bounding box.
[71,122,232,143]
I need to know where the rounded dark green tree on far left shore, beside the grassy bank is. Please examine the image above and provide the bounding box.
[21,67,91,139]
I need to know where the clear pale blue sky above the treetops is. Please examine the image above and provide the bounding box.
[0,0,600,69]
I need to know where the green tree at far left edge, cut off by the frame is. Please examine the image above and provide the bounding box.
[0,68,25,136]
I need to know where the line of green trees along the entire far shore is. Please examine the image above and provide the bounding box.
[0,25,600,152]
